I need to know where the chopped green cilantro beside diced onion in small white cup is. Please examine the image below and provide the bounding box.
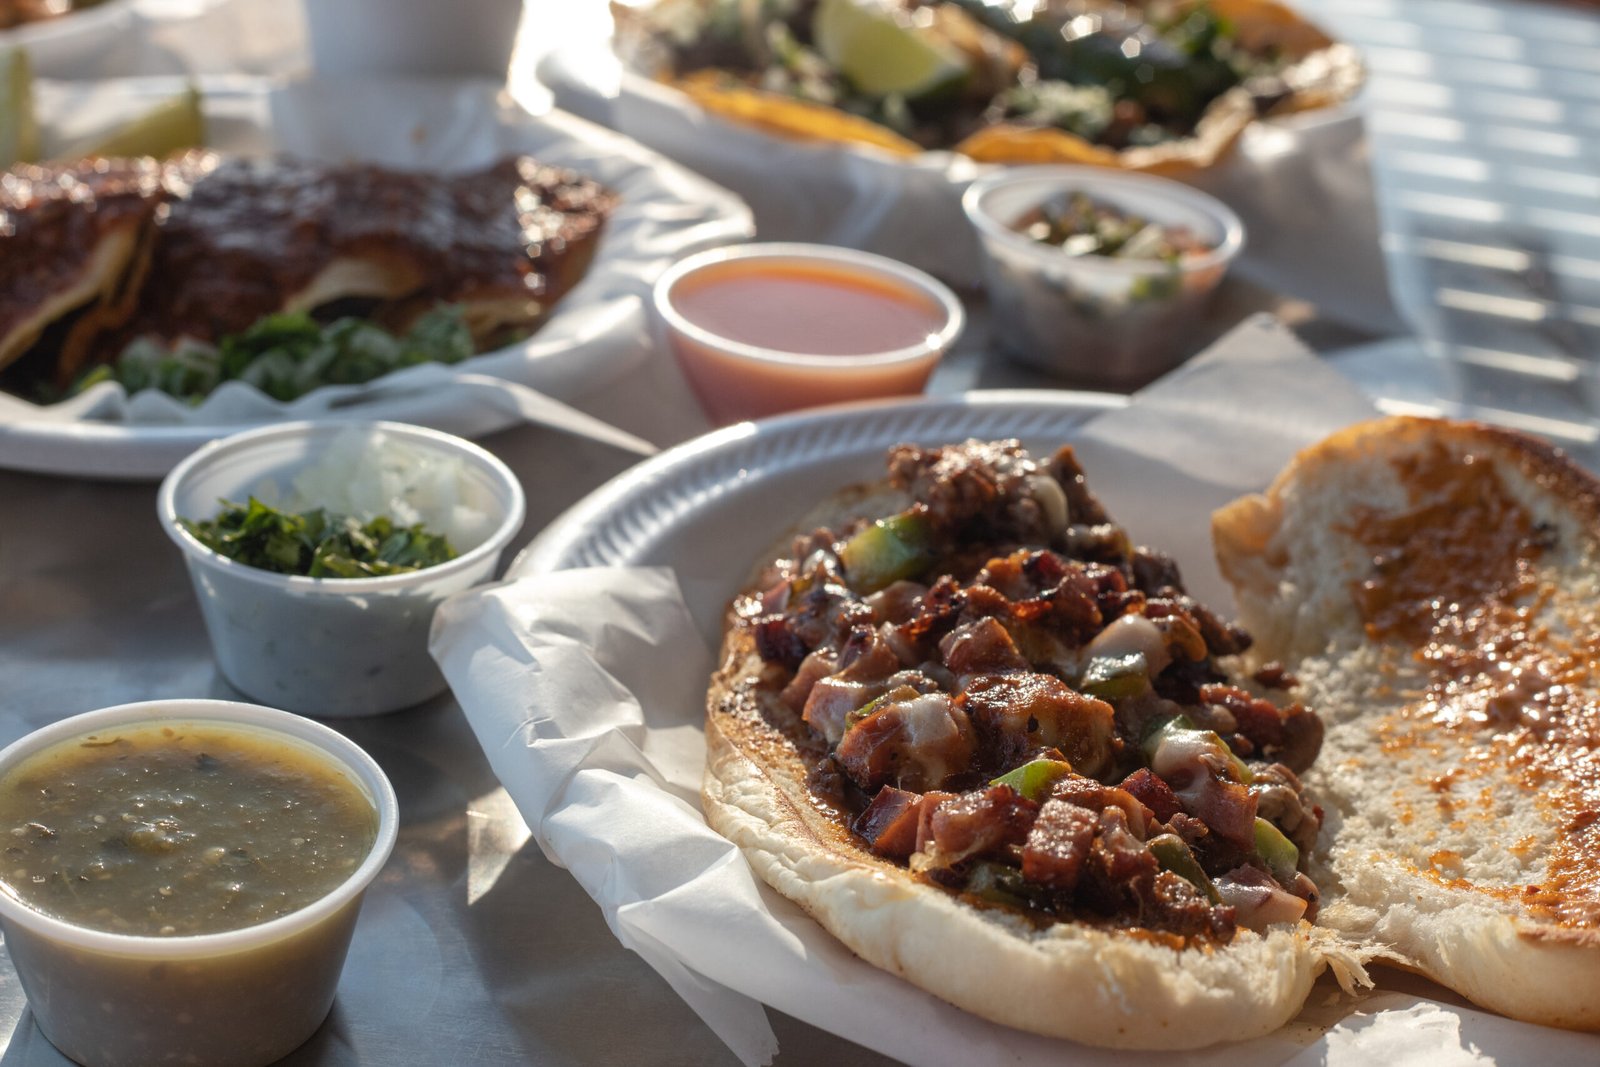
[178,496,458,577]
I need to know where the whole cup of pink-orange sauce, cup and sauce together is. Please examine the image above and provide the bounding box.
[654,243,966,426]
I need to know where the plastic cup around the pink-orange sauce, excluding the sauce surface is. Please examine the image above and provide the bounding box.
[654,243,966,424]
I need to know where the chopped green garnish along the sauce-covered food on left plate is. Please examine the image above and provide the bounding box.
[72,306,474,403]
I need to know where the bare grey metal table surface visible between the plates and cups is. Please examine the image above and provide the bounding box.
[0,0,1600,1067]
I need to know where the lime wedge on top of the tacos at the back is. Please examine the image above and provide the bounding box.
[811,0,966,101]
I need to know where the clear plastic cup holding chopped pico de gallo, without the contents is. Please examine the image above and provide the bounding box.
[962,166,1245,389]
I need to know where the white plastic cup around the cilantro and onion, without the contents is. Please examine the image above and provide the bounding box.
[155,422,525,718]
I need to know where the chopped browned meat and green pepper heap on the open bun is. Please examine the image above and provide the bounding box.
[734,442,1322,941]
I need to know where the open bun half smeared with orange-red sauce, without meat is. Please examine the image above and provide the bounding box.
[1213,418,1600,1030]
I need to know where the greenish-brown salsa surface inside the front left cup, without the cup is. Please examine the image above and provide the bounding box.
[0,723,378,937]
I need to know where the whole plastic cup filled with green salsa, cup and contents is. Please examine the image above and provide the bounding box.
[0,701,400,1067]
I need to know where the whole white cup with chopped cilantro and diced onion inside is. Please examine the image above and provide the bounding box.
[157,422,525,717]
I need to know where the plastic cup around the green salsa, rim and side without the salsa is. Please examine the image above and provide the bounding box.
[0,701,400,1067]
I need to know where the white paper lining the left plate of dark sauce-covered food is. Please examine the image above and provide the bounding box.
[0,78,752,437]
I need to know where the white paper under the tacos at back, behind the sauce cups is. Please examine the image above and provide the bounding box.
[538,38,1410,333]
